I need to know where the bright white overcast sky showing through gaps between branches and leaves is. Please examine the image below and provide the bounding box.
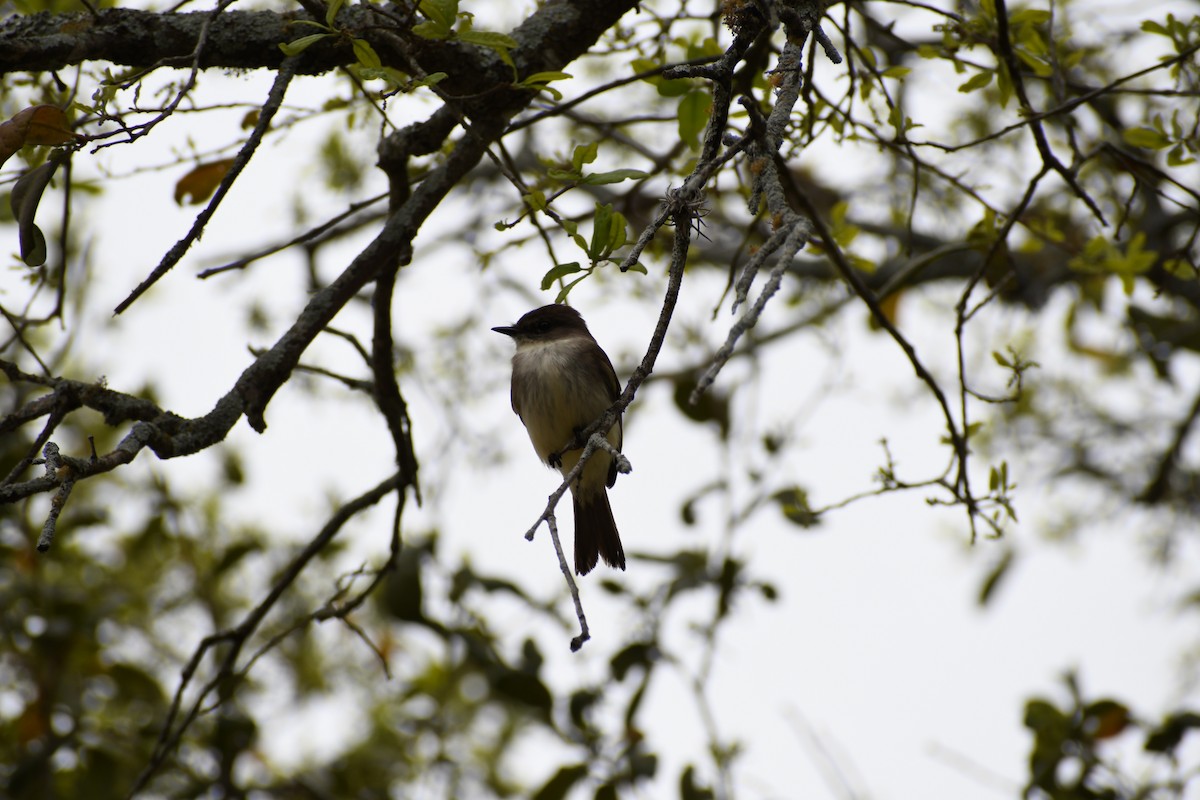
[9,2,1198,800]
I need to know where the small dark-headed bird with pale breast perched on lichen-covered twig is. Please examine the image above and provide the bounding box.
[492,306,625,575]
